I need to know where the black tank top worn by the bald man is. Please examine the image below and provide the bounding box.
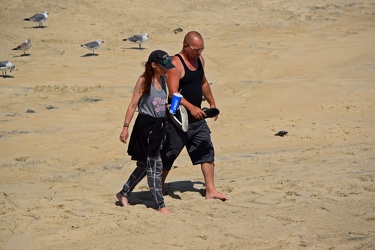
[176,54,204,108]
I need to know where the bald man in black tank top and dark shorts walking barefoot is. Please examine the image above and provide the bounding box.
[161,31,228,201]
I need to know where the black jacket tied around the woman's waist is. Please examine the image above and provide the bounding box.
[128,114,165,161]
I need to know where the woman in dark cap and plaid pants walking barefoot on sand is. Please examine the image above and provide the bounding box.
[116,50,174,213]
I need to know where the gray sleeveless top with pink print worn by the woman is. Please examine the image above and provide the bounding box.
[138,77,167,118]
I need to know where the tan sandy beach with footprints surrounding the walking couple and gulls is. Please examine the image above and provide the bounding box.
[0,0,375,250]
